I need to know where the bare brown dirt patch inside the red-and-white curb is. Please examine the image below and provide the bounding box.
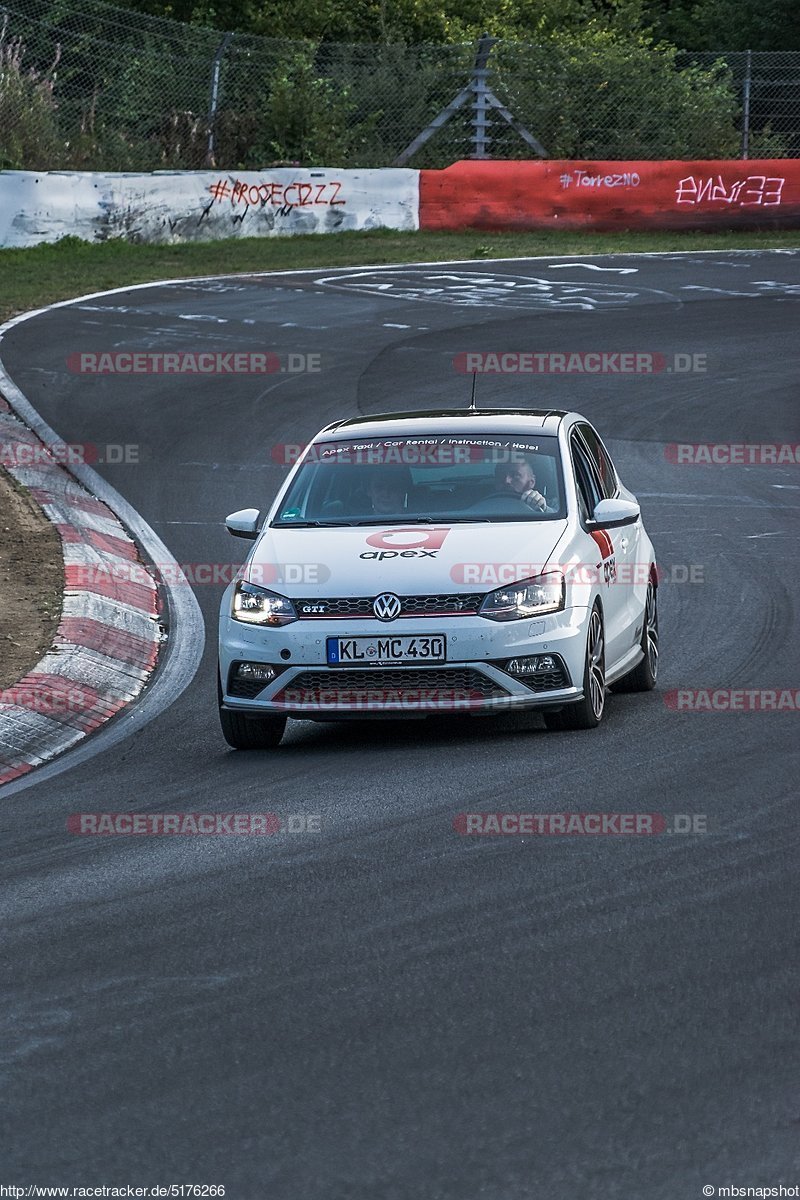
[0,468,64,688]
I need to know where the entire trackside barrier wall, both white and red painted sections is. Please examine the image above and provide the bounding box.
[0,158,800,246]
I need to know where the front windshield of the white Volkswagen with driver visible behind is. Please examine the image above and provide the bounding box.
[272,433,566,526]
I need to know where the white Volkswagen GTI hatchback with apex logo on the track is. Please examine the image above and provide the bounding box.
[218,410,658,749]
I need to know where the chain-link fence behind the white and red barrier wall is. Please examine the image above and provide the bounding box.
[0,0,800,172]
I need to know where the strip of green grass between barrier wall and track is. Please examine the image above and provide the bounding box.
[0,230,800,322]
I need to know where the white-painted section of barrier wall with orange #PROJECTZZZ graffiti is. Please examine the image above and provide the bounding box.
[0,168,420,246]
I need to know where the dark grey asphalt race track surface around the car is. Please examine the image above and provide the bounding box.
[0,252,800,1200]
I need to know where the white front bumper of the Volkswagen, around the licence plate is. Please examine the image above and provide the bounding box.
[219,602,589,721]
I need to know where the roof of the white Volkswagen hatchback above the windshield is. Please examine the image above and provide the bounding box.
[314,408,579,442]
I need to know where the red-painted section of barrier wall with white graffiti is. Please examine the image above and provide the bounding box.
[420,158,800,229]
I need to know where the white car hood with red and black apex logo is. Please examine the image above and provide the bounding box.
[243,521,567,598]
